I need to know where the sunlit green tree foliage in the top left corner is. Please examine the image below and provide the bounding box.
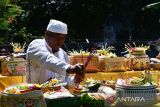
[0,0,22,44]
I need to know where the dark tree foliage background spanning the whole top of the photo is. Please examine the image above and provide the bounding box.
[0,0,160,44]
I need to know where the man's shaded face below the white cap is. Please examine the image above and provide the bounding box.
[45,31,66,50]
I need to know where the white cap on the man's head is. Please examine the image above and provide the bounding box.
[47,19,68,34]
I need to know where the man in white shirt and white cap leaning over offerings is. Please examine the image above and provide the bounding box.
[27,19,84,83]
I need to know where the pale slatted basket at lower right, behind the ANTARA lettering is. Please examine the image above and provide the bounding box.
[116,85,157,107]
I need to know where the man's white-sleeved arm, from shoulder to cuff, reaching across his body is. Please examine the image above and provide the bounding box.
[27,41,71,75]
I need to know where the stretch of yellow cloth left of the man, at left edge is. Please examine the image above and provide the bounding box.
[0,75,26,91]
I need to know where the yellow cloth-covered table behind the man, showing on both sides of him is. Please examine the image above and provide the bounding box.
[0,70,160,91]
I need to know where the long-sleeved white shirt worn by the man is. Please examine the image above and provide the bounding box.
[26,39,71,83]
